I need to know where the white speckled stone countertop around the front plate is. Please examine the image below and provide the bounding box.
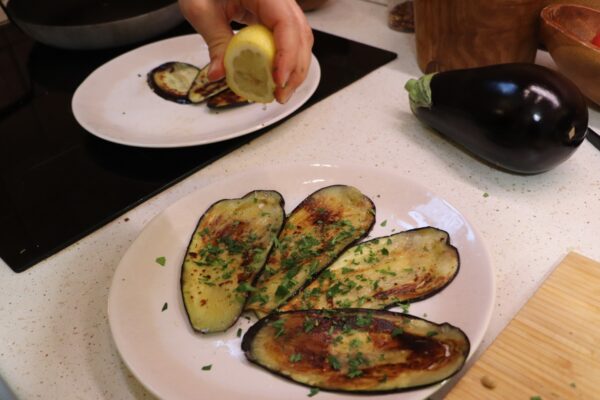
[0,0,600,400]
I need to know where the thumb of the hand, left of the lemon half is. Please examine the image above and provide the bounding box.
[179,0,233,81]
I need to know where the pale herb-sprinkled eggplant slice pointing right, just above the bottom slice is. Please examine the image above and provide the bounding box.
[281,227,459,311]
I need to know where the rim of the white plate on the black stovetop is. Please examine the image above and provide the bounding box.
[71,33,321,149]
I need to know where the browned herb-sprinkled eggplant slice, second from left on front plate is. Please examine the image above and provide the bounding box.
[246,185,375,317]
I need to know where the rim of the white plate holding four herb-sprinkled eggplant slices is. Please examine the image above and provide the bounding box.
[107,162,497,398]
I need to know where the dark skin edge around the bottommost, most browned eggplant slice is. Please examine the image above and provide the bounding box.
[241,308,471,395]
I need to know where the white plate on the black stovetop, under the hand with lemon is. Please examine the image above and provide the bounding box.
[71,34,321,147]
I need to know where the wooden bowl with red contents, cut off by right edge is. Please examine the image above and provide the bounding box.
[540,4,600,105]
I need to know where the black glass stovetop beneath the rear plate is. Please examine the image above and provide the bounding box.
[0,23,396,272]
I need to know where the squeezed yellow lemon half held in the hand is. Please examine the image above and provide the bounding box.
[224,25,275,103]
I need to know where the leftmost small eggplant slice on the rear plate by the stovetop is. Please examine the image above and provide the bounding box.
[148,61,200,104]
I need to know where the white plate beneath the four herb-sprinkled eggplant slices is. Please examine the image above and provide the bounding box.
[108,164,495,400]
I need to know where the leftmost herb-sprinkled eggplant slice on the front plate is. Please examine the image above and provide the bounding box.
[181,191,285,333]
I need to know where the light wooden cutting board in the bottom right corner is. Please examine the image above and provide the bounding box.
[445,253,600,400]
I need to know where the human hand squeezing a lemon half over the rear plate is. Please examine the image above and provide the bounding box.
[179,0,313,103]
